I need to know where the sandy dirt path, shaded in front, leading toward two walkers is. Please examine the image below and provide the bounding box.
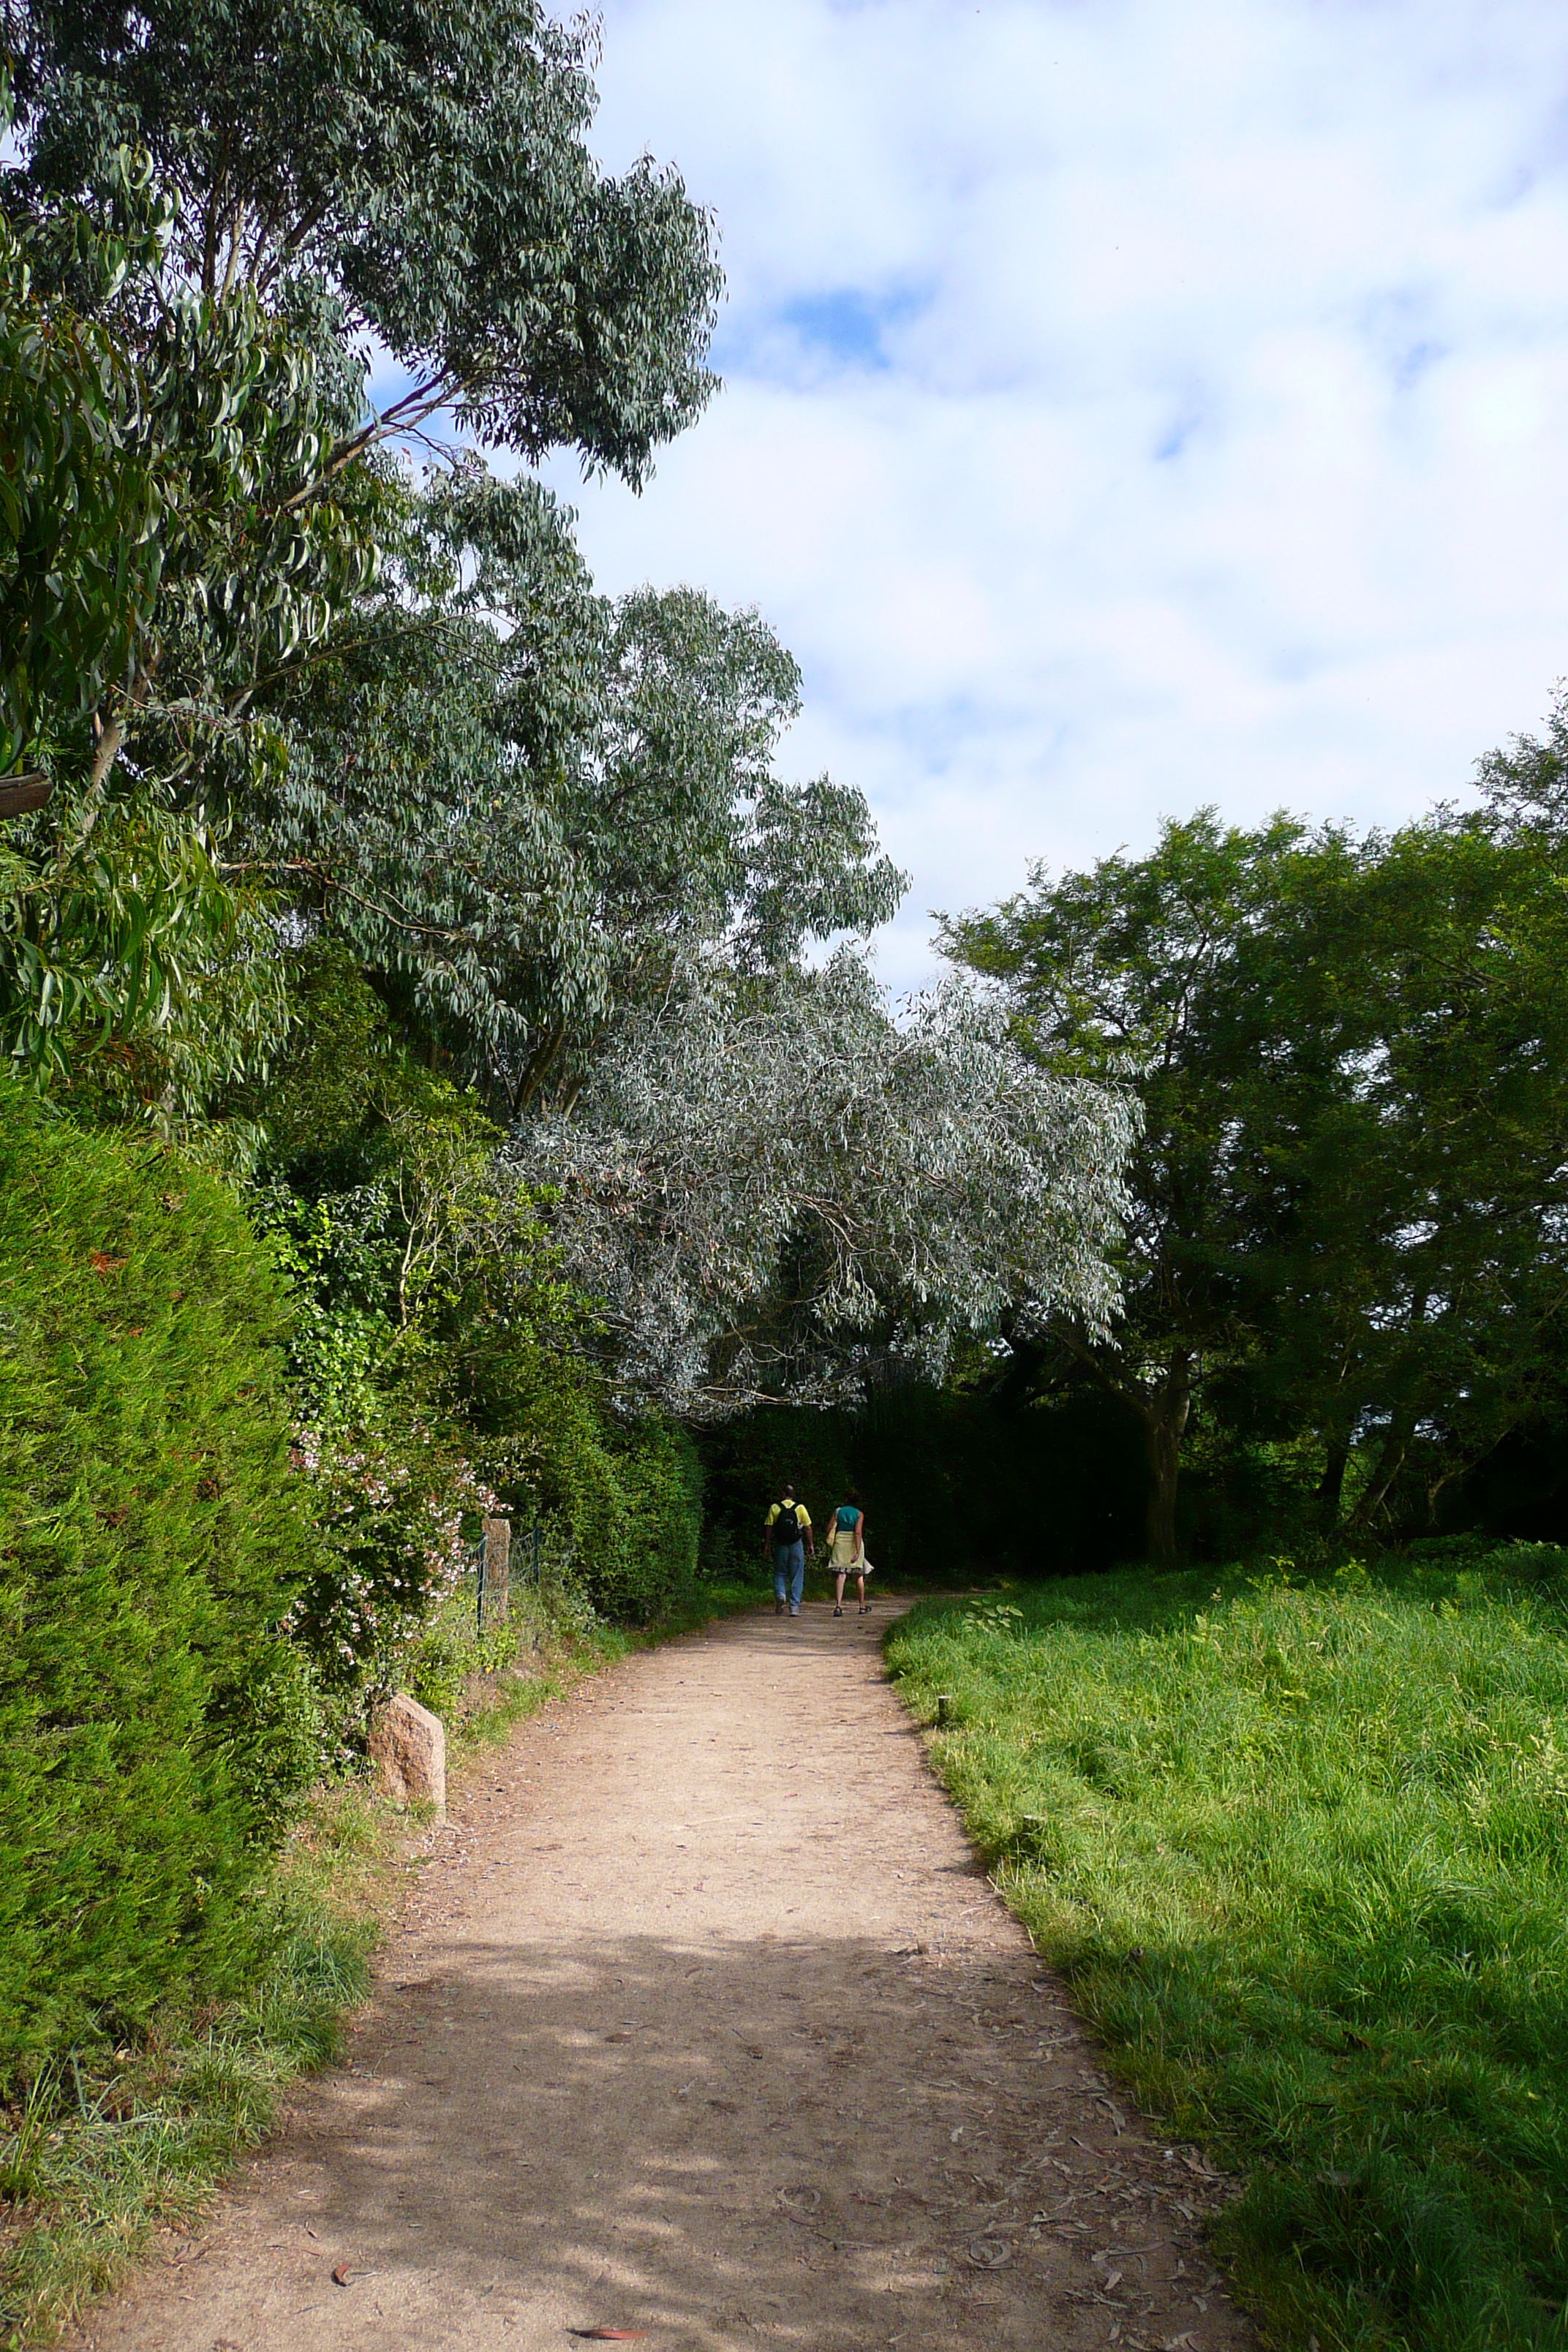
[83,1607,1251,2352]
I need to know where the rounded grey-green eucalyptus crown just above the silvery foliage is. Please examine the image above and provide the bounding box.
[242,464,902,1117]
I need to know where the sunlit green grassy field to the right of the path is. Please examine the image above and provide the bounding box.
[889,1548,1568,2352]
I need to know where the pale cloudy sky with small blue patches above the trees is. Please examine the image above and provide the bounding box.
[535,0,1568,986]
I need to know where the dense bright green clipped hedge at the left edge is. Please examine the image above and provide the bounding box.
[0,1085,315,2072]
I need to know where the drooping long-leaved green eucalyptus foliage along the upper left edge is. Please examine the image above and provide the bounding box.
[0,142,374,1093]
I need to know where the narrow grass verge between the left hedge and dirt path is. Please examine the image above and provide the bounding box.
[0,1586,759,2352]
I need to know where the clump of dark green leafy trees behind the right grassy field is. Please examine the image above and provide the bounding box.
[945,809,1568,1564]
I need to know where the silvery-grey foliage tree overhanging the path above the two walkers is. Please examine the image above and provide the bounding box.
[515,950,1133,1414]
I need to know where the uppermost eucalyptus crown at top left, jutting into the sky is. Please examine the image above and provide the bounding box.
[7,0,720,482]
